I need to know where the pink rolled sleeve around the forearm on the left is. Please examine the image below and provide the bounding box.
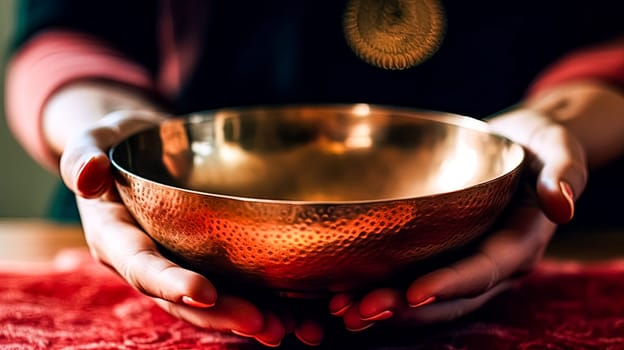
[5,30,154,171]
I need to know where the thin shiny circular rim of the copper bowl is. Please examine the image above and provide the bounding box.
[107,103,526,206]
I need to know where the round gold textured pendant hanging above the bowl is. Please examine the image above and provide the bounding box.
[343,0,446,70]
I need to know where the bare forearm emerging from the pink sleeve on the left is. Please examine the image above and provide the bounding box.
[42,81,162,163]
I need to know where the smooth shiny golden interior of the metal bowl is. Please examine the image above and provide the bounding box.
[111,104,524,202]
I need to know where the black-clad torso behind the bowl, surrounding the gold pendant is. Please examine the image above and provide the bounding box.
[176,0,624,118]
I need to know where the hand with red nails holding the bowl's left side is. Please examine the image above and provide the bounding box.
[60,111,302,346]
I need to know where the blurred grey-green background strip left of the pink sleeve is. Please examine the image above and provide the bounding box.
[0,0,58,217]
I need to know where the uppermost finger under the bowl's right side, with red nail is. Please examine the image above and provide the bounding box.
[406,207,555,306]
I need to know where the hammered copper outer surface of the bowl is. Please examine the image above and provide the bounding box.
[116,167,521,294]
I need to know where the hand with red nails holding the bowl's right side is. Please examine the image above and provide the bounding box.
[329,109,587,331]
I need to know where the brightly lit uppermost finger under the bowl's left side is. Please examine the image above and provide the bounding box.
[77,197,217,307]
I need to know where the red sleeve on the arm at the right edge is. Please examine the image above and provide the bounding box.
[528,37,624,95]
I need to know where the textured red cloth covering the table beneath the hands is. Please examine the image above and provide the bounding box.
[0,253,624,350]
